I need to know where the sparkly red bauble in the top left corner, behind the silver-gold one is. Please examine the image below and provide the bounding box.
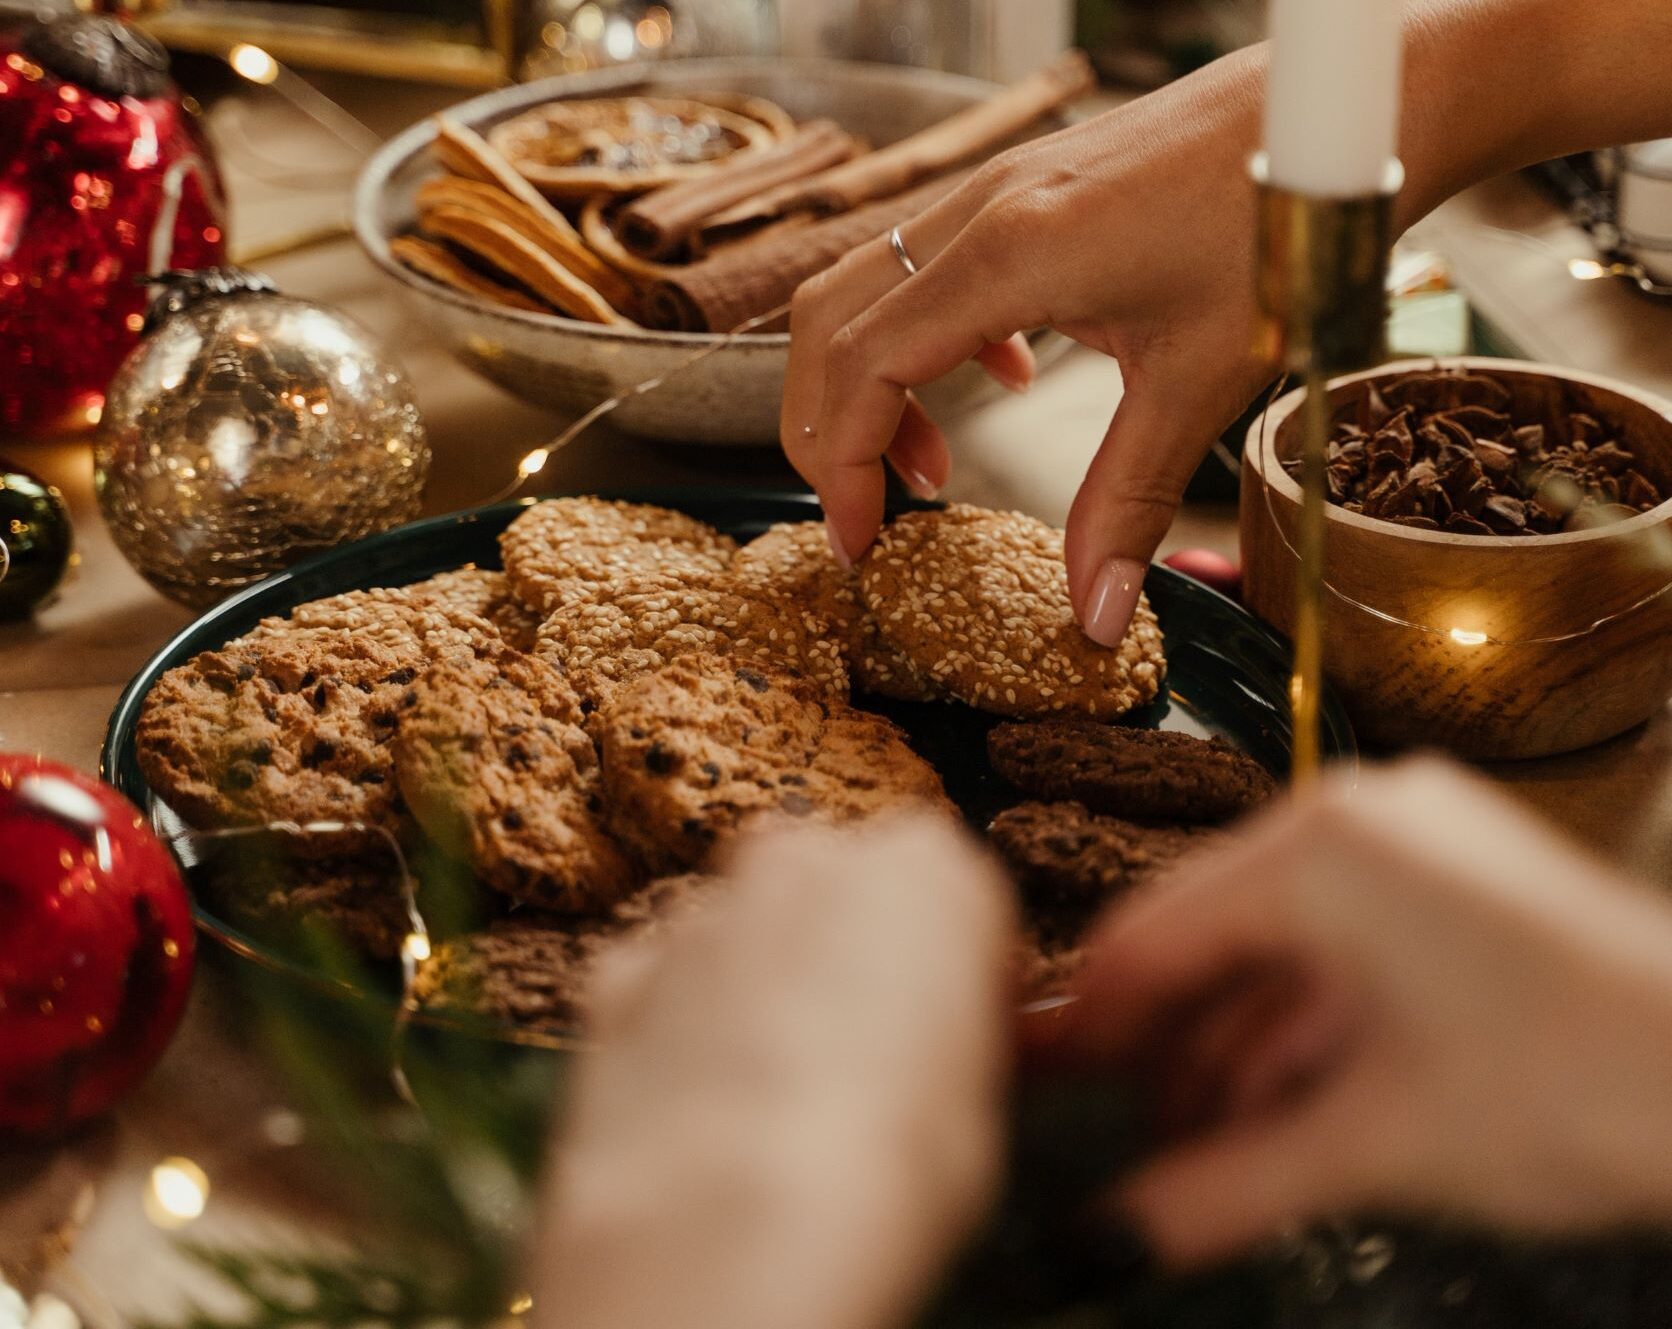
[0,15,226,435]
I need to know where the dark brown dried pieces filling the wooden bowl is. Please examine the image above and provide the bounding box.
[1282,368,1669,535]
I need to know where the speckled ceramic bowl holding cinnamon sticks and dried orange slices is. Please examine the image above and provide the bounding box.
[354,59,1056,446]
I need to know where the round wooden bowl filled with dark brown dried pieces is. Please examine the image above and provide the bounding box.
[1242,356,1672,759]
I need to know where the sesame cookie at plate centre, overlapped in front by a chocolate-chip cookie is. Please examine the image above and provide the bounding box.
[535,575,848,705]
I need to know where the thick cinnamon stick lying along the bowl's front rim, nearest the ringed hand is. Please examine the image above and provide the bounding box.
[645,171,970,333]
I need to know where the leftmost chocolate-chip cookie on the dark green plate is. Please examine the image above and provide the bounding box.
[137,630,431,854]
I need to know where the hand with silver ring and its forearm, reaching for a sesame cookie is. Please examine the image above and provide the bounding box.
[781,0,1672,645]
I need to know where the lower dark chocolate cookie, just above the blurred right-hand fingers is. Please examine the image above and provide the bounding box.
[988,802,1219,943]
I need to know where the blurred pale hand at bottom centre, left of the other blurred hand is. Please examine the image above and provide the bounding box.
[535,822,1012,1329]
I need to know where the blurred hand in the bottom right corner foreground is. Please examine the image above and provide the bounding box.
[1052,762,1672,1262]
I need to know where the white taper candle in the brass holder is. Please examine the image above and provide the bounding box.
[1266,0,1403,197]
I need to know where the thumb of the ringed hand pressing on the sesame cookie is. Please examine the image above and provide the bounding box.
[1067,356,1259,647]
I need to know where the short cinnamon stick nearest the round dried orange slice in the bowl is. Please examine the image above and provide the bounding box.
[620,120,859,259]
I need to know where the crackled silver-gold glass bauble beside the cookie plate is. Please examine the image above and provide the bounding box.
[94,267,430,608]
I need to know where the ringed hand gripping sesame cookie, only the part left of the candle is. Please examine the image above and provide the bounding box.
[782,55,1266,645]
